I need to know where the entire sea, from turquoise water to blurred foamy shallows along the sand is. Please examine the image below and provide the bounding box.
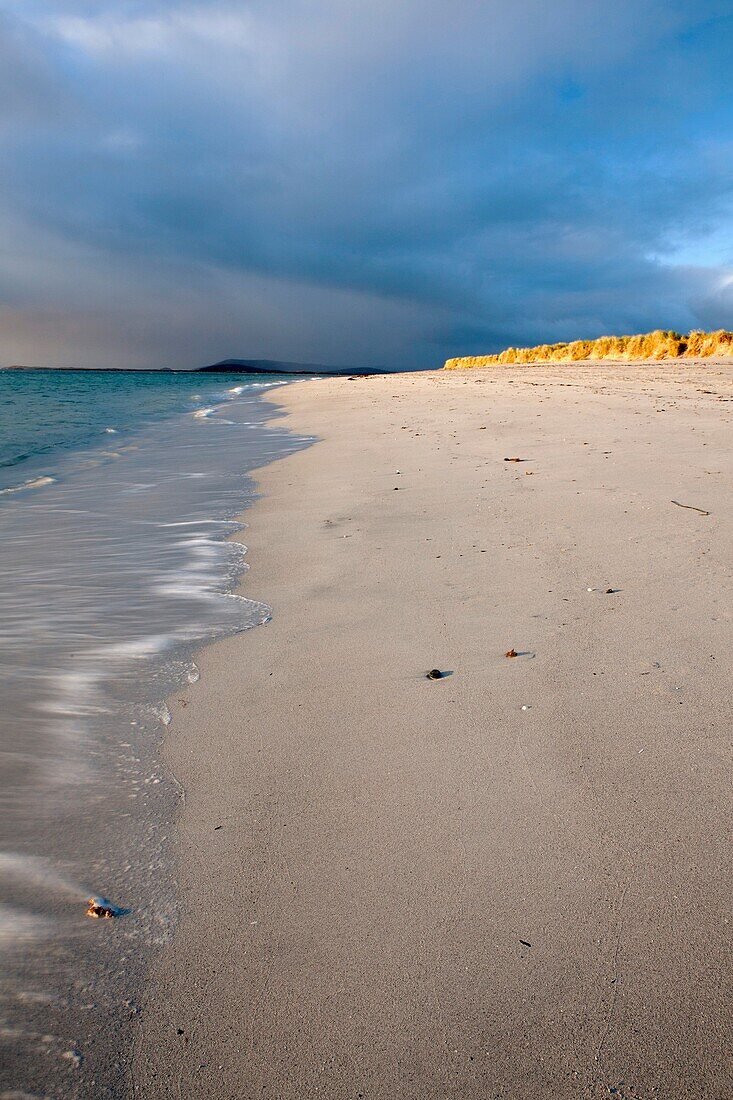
[0,371,307,1097]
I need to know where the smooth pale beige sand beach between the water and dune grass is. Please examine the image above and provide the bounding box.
[133,363,733,1100]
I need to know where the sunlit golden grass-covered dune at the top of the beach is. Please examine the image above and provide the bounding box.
[445,329,733,371]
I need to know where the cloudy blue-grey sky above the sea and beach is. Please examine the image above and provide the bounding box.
[0,0,733,369]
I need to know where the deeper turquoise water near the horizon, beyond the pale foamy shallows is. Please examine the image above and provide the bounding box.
[0,371,248,490]
